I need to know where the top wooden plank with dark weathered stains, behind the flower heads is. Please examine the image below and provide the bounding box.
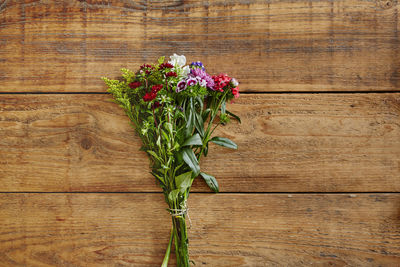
[0,0,400,92]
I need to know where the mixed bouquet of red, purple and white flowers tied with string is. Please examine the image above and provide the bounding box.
[103,54,240,266]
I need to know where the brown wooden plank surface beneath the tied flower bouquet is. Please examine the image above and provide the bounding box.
[0,0,400,267]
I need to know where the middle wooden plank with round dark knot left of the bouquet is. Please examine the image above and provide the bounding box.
[0,93,400,192]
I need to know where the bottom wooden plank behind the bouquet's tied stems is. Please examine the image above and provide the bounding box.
[0,193,400,267]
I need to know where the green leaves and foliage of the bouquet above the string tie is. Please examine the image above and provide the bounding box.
[102,60,240,195]
